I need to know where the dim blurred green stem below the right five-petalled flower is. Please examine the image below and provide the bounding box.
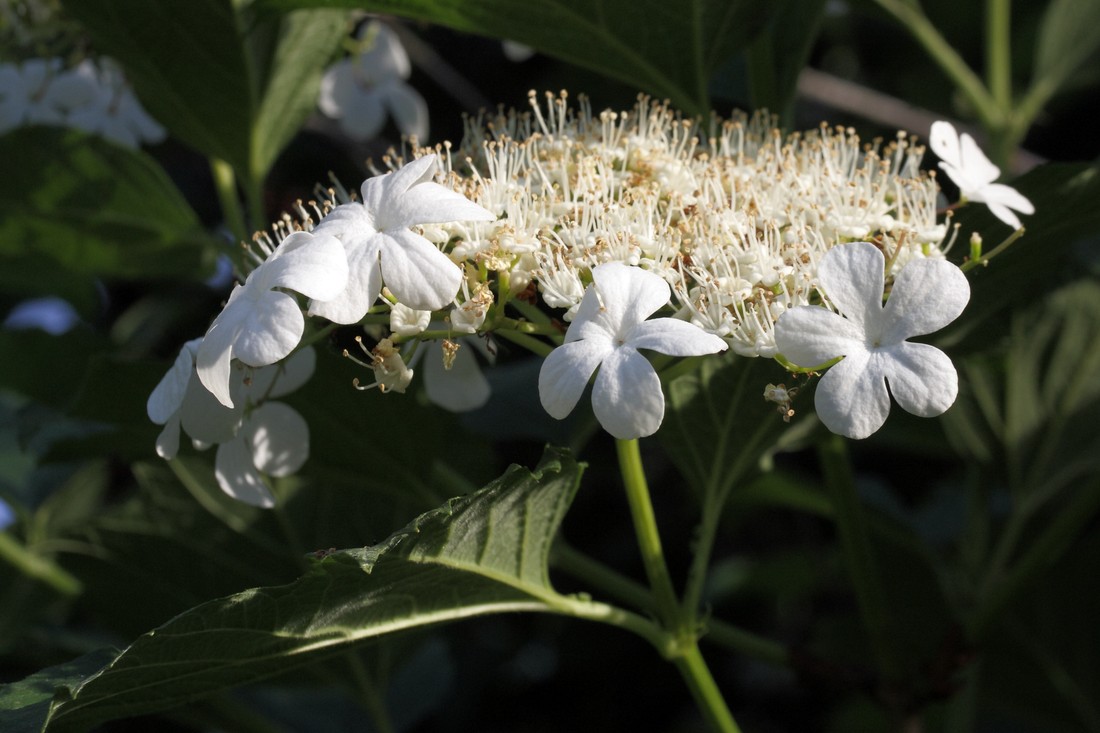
[818,434,904,685]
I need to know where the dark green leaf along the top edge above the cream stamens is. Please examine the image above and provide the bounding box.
[256,0,776,114]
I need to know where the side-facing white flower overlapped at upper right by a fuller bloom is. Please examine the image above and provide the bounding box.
[195,231,348,407]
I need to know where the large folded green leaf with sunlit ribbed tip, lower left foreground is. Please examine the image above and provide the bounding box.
[36,450,584,730]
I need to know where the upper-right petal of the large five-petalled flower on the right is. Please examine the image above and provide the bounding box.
[880,260,970,346]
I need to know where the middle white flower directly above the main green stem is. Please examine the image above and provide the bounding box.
[539,262,726,439]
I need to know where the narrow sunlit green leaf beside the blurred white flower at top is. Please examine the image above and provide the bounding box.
[252,10,348,177]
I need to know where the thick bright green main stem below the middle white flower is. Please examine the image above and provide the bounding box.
[615,439,740,733]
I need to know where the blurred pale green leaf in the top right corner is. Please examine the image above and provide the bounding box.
[1033,0,1100,95]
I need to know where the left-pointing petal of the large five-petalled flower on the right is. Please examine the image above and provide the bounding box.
[776,306,867,367]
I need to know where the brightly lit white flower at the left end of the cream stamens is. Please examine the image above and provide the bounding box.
[309,155,496,324]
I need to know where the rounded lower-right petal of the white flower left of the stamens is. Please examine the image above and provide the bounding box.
[382,229,462,310]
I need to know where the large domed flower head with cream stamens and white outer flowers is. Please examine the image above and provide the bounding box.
[151,94,1034,497]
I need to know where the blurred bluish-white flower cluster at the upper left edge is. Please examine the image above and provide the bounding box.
[0,58,165,147]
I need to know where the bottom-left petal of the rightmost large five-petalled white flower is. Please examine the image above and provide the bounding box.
[814,351,890,440]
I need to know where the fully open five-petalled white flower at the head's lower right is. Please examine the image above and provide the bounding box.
[776,242,970,438]
